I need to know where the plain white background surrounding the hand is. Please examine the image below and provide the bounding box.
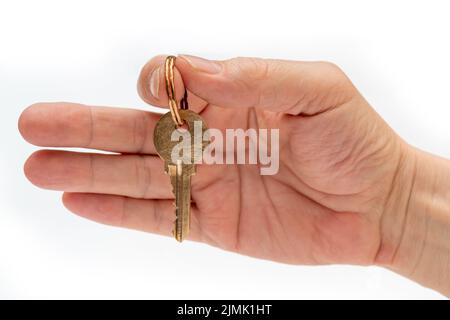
[0,0,450,299]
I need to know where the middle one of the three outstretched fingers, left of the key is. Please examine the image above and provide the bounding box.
[24,150,173,199]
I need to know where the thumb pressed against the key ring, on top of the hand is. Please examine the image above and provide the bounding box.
[176,55,357,115]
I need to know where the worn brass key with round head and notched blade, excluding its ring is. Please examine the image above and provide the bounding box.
[154,110,208,242]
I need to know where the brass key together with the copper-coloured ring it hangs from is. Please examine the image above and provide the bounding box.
[153,56,209,242]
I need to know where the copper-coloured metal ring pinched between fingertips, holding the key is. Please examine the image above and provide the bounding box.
[164,56,189,126]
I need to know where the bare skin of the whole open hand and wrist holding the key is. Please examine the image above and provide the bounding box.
[19,56,450,295]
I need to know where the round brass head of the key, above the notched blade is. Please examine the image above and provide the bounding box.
[153,109,209,168]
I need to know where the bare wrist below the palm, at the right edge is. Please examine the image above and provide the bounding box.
[377,145,450,296]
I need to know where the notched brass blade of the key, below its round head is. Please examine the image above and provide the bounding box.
[167,160,195,242]
